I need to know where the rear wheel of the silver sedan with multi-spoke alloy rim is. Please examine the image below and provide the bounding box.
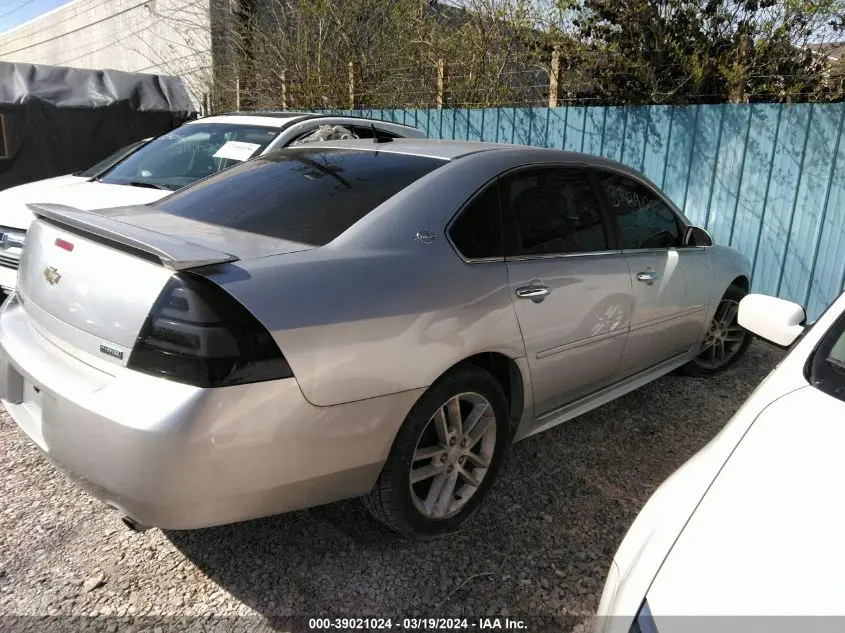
[364,366,511,540]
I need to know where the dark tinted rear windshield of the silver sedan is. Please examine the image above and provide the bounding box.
[152,147,446,246]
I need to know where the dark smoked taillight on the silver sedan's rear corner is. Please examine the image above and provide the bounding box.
[127,273,293,387]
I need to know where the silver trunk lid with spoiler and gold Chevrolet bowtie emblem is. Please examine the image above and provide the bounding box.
[18,204,308,370]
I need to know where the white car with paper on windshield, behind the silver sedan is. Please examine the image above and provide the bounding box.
[0,112,425,291]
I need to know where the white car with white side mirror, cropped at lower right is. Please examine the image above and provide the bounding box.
[593,294,845,633]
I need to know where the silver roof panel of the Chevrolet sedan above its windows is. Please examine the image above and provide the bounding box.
[304,138,644,172]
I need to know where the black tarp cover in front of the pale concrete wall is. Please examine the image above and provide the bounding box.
[0,62,197,190]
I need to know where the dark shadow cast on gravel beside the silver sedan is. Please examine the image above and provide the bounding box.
[166,342,782,630]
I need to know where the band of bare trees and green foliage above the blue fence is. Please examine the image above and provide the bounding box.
[145,0,845,110]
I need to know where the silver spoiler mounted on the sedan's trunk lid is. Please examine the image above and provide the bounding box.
[26,203,238,270]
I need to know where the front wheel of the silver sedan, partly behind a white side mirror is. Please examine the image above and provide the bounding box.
[681,286,752,376]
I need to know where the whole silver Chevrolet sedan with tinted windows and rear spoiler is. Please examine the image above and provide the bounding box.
[0,139,750,538]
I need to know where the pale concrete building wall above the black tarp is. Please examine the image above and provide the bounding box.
[0,0,212,107]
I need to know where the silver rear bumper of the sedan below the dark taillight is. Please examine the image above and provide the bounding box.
[0,296,421,529]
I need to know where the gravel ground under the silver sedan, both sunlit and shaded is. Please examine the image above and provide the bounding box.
[0,342,781,632]
